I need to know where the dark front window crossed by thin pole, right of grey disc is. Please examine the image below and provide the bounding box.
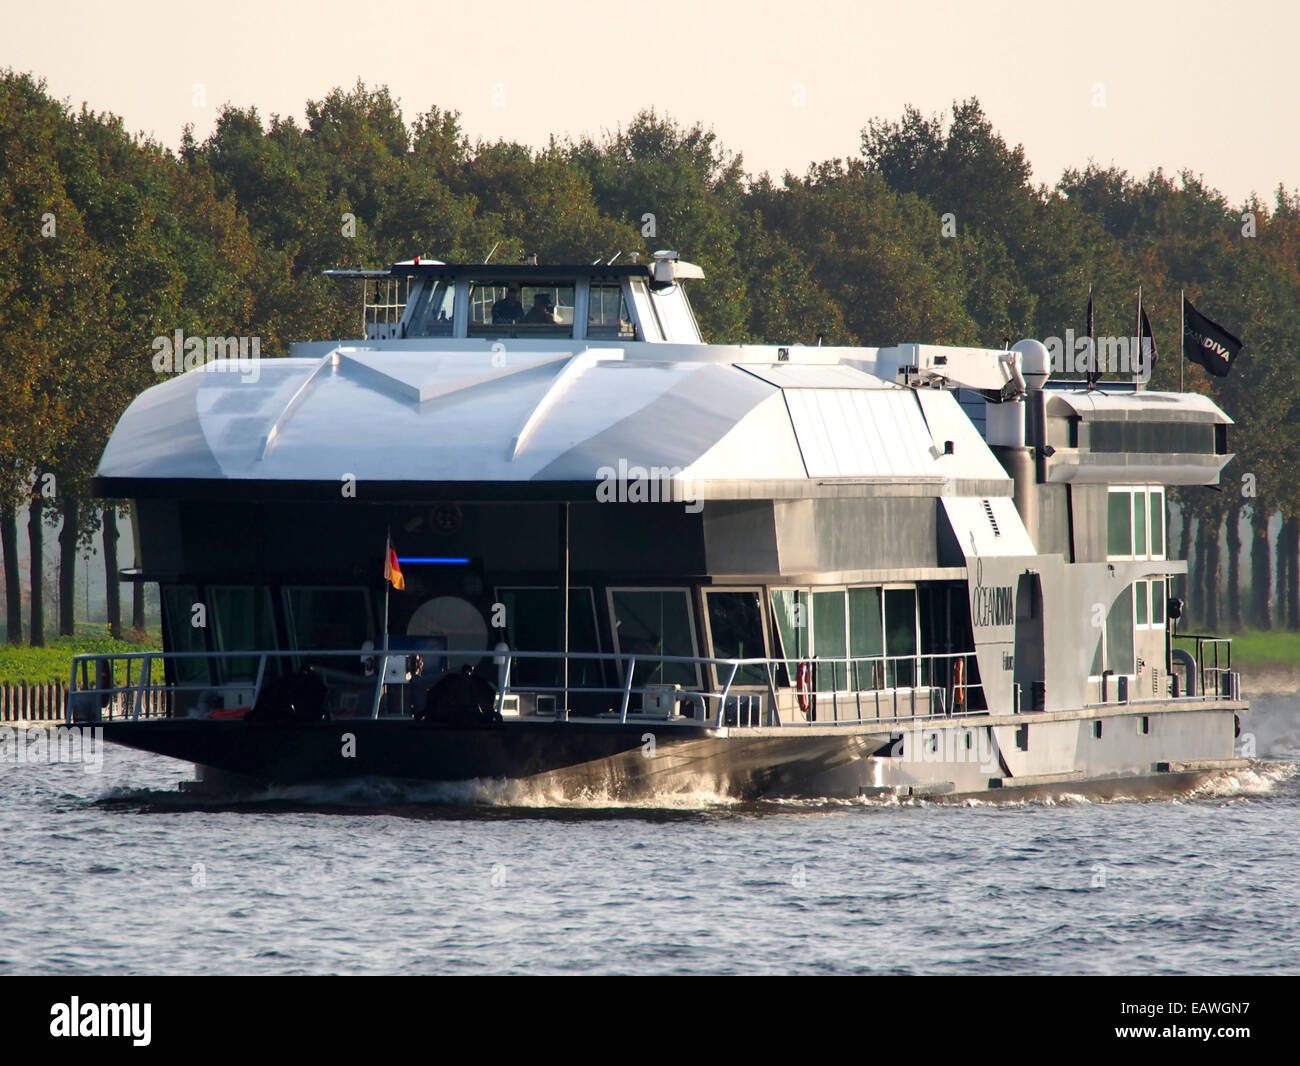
[497,585,605,688]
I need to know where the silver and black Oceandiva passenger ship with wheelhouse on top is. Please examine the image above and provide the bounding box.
[78,252,1245,798]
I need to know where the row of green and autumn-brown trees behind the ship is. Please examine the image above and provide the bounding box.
[0,70,1300,644]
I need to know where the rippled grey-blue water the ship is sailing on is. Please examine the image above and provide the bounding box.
[0,696,1300,974]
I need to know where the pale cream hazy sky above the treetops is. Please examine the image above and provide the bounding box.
[0,0,1300,202]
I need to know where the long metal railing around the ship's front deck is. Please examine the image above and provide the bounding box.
[68,649,983,728]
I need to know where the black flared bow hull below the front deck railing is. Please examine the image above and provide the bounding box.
[103,719,880,800]
